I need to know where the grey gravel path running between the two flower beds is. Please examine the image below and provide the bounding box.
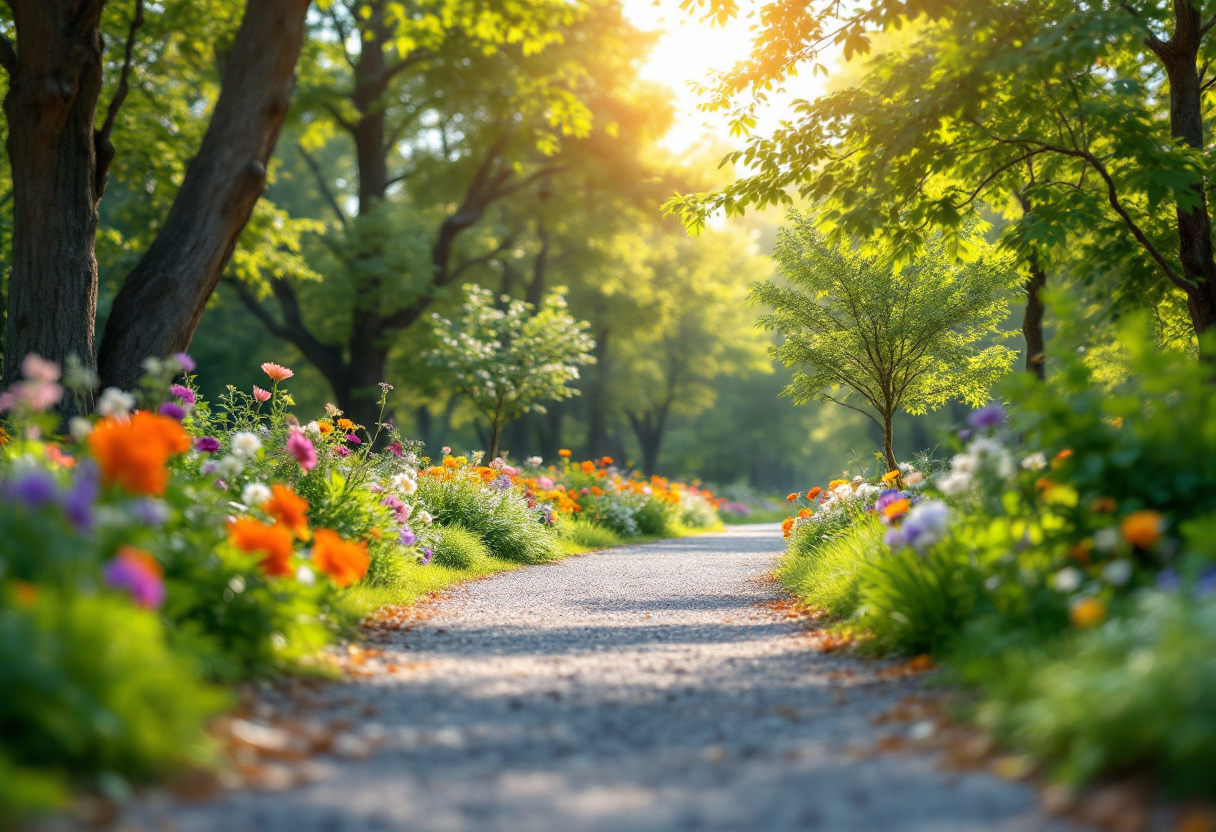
[135,525,1071,832]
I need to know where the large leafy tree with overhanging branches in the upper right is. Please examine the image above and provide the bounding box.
[674,0,1216,355]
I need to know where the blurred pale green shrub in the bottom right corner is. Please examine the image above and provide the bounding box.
[980,592,1216,796]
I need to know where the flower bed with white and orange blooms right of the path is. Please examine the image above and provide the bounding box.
[781,316,1216,797]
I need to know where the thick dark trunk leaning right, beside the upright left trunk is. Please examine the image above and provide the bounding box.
[98,0,309,388]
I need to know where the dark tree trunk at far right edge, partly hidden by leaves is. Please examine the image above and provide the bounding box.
[1156,0,1216,333]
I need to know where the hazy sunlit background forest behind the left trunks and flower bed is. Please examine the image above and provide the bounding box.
[0,0,977,493]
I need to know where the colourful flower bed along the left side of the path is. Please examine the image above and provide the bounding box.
[0,355,717,822]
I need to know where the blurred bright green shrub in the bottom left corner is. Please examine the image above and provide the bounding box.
[0,588,227,796]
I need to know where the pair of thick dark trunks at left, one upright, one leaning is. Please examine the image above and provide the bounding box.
[0,0,309,387]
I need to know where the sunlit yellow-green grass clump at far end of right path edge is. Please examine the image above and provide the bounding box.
[777,517,884,617]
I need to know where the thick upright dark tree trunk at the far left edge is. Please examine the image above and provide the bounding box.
[0,0,105,383]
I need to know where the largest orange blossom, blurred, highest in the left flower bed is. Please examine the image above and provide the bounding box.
[89,411,190,495]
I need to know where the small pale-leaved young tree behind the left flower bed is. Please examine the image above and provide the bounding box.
[428,285,595,459]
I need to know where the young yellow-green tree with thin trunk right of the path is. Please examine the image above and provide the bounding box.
[751,212,1019,470]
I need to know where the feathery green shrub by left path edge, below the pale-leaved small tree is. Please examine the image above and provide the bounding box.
[416,477,561,563]
